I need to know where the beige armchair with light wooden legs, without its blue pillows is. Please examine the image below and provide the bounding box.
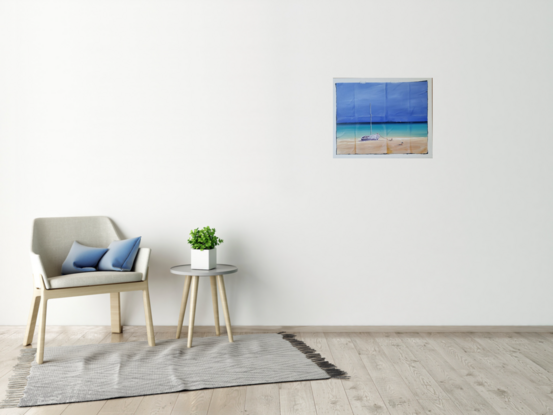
[23,216,155,364]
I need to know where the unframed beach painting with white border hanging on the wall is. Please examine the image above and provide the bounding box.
[334,78,432,158]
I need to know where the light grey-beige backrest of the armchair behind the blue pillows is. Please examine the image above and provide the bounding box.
[31,216,123,277]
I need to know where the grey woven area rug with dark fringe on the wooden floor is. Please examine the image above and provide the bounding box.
[0,333,347,408]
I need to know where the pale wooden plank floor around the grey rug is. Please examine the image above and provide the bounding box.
[0,326,553,415]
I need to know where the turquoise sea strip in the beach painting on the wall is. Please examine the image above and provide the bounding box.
[336,122,428,140]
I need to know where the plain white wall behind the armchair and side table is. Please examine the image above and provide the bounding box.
[0,0,553,325]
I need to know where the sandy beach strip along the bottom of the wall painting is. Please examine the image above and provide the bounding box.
[336,137,428,154]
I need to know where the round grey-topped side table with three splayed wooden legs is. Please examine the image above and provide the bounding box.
[171,264,238,347]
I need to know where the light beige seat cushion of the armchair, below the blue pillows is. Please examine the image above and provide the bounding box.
[48,271,143,289]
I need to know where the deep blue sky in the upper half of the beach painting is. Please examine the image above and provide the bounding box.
[336,81,428,124]
